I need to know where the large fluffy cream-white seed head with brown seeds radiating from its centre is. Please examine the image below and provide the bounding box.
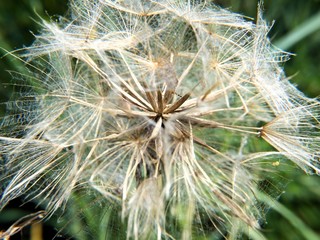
[0,0,320,239]
